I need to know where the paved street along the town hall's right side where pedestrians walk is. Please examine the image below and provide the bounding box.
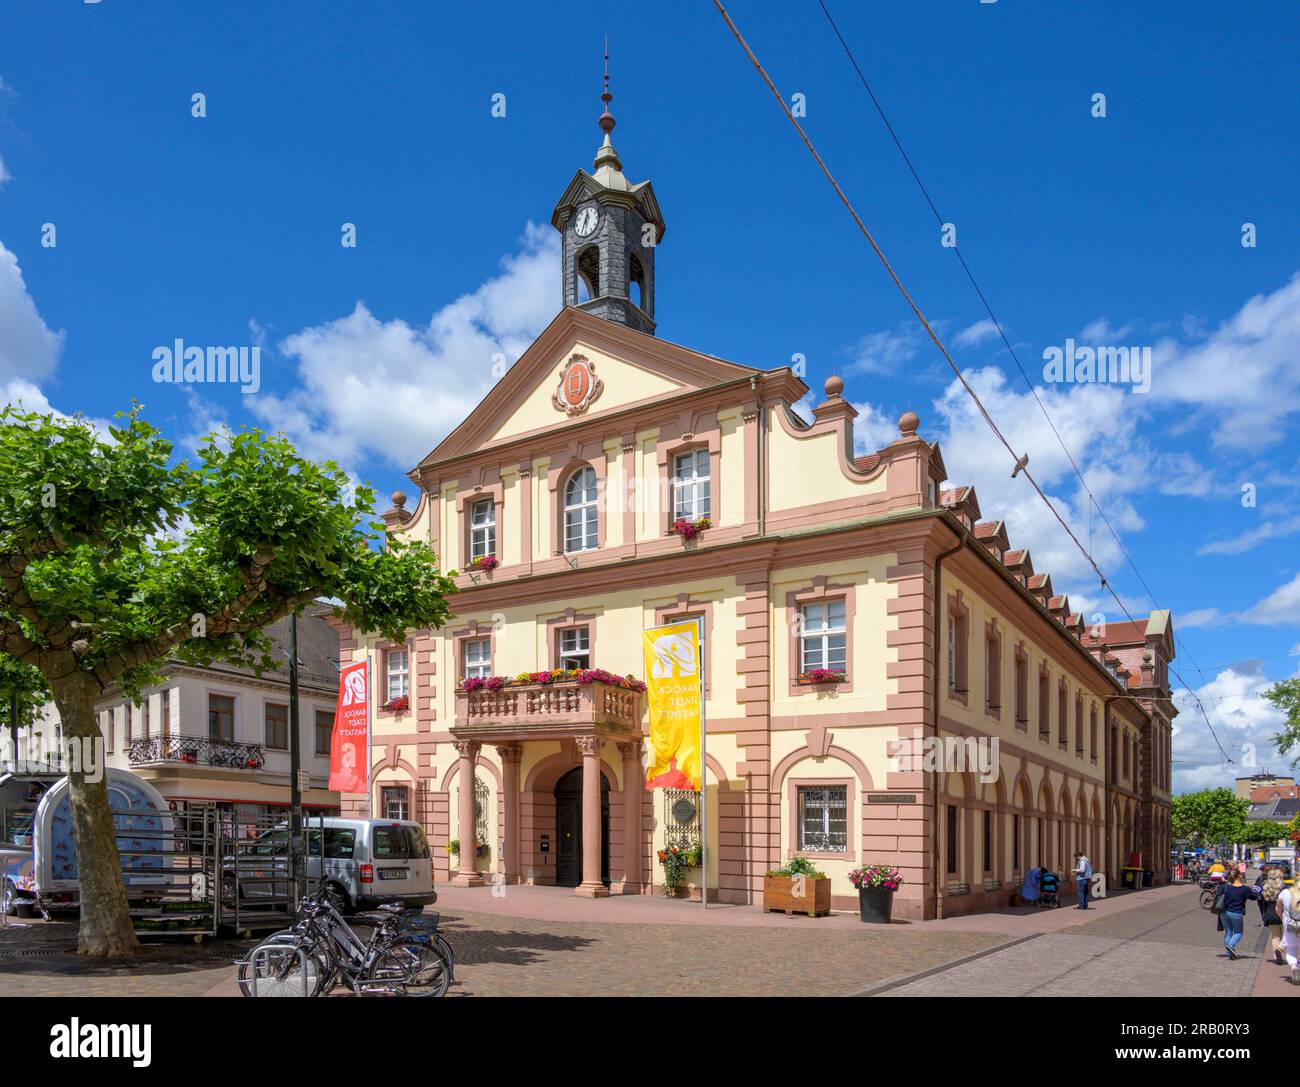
[880,888,1300,996]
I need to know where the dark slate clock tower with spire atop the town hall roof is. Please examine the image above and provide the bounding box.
[551,47,664,335]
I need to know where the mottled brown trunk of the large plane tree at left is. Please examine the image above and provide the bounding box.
[52,675,139,957]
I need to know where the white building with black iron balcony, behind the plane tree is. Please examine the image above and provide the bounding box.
[85,609,339,827]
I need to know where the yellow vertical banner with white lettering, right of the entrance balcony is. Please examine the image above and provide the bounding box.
[641,619,705,792]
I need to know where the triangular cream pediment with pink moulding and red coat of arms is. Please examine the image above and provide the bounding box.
[419,307,763,468]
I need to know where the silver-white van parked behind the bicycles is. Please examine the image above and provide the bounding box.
[239,815,438,913]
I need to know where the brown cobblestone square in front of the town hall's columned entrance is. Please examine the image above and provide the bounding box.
[0,911,1006,996]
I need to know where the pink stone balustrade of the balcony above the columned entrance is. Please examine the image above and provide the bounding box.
[452,683,645,736]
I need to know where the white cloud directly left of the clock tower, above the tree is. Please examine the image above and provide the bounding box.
[250,224,559,469]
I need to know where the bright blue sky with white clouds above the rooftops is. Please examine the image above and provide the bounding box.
[0,0,1300,787]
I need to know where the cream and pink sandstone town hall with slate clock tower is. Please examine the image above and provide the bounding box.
[341,89,1174,918]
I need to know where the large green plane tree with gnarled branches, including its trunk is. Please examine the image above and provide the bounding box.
[0,407,455,956]
